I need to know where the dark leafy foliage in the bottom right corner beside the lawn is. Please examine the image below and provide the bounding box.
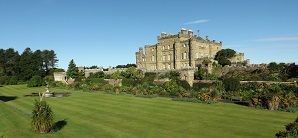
[275,117,298,138]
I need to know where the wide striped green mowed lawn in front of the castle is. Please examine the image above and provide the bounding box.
[0,85,298,138]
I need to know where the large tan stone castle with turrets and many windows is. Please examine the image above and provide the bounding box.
[136,28,244,71]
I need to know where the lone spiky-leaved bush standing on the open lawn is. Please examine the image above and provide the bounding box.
[31,100,53,133]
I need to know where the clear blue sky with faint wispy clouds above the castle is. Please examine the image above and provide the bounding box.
[0,0,298,68]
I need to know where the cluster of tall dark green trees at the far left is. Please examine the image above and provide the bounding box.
[0,48,58,84]
